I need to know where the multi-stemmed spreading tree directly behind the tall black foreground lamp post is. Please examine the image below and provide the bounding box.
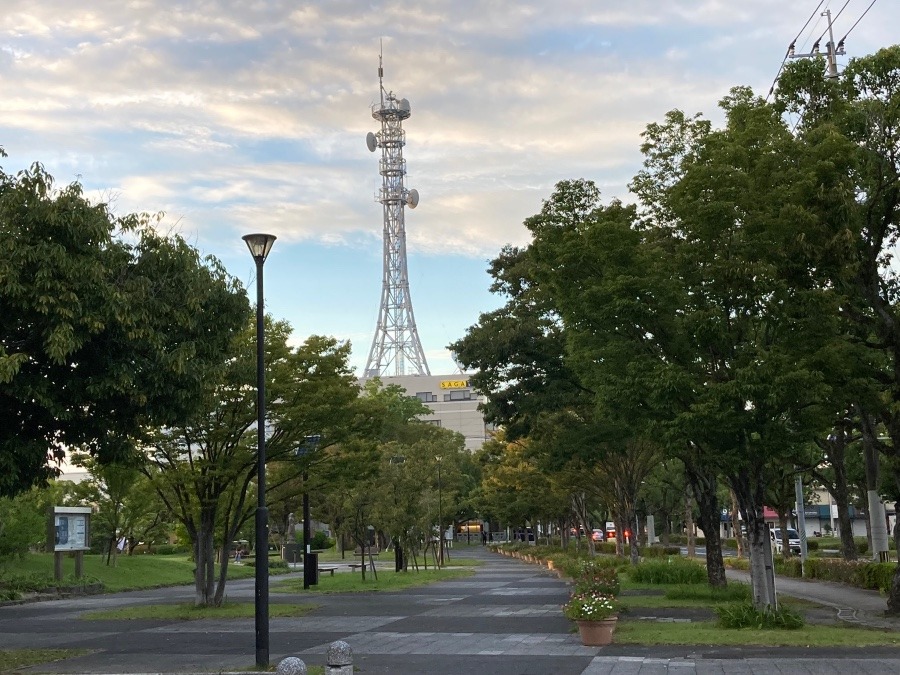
[145,320,358,606]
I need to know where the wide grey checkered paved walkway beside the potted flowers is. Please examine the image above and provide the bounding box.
[0,547,900,675]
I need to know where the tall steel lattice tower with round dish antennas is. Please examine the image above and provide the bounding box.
[365,55,431,377]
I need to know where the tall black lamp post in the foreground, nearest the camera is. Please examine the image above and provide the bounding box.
[242,234,275,668]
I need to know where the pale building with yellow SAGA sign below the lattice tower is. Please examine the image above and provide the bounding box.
[368,373,492,452]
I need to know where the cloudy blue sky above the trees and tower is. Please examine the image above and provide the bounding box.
[0,0,900,374]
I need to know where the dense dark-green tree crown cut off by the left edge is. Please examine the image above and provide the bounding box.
[0,157,248,495]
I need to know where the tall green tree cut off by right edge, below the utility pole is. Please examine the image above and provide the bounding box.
[777,45,900,614]
